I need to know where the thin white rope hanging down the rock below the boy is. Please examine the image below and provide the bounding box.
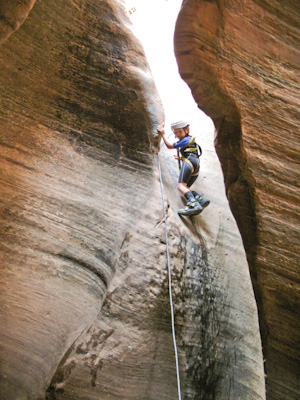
[157,156,181,400]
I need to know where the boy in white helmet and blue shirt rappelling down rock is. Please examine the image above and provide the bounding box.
[157,121,210,216]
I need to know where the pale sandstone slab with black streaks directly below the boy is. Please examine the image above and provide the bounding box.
[47,143,265,400]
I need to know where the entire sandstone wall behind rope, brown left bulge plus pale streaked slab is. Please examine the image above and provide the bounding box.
[0,0,265,400]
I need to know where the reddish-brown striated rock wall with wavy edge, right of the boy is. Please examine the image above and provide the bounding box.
[175,0,300,400]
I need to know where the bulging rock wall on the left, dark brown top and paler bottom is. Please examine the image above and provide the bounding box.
[0,1,160,400]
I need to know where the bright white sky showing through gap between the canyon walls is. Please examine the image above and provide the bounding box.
[125,0,213,144]
